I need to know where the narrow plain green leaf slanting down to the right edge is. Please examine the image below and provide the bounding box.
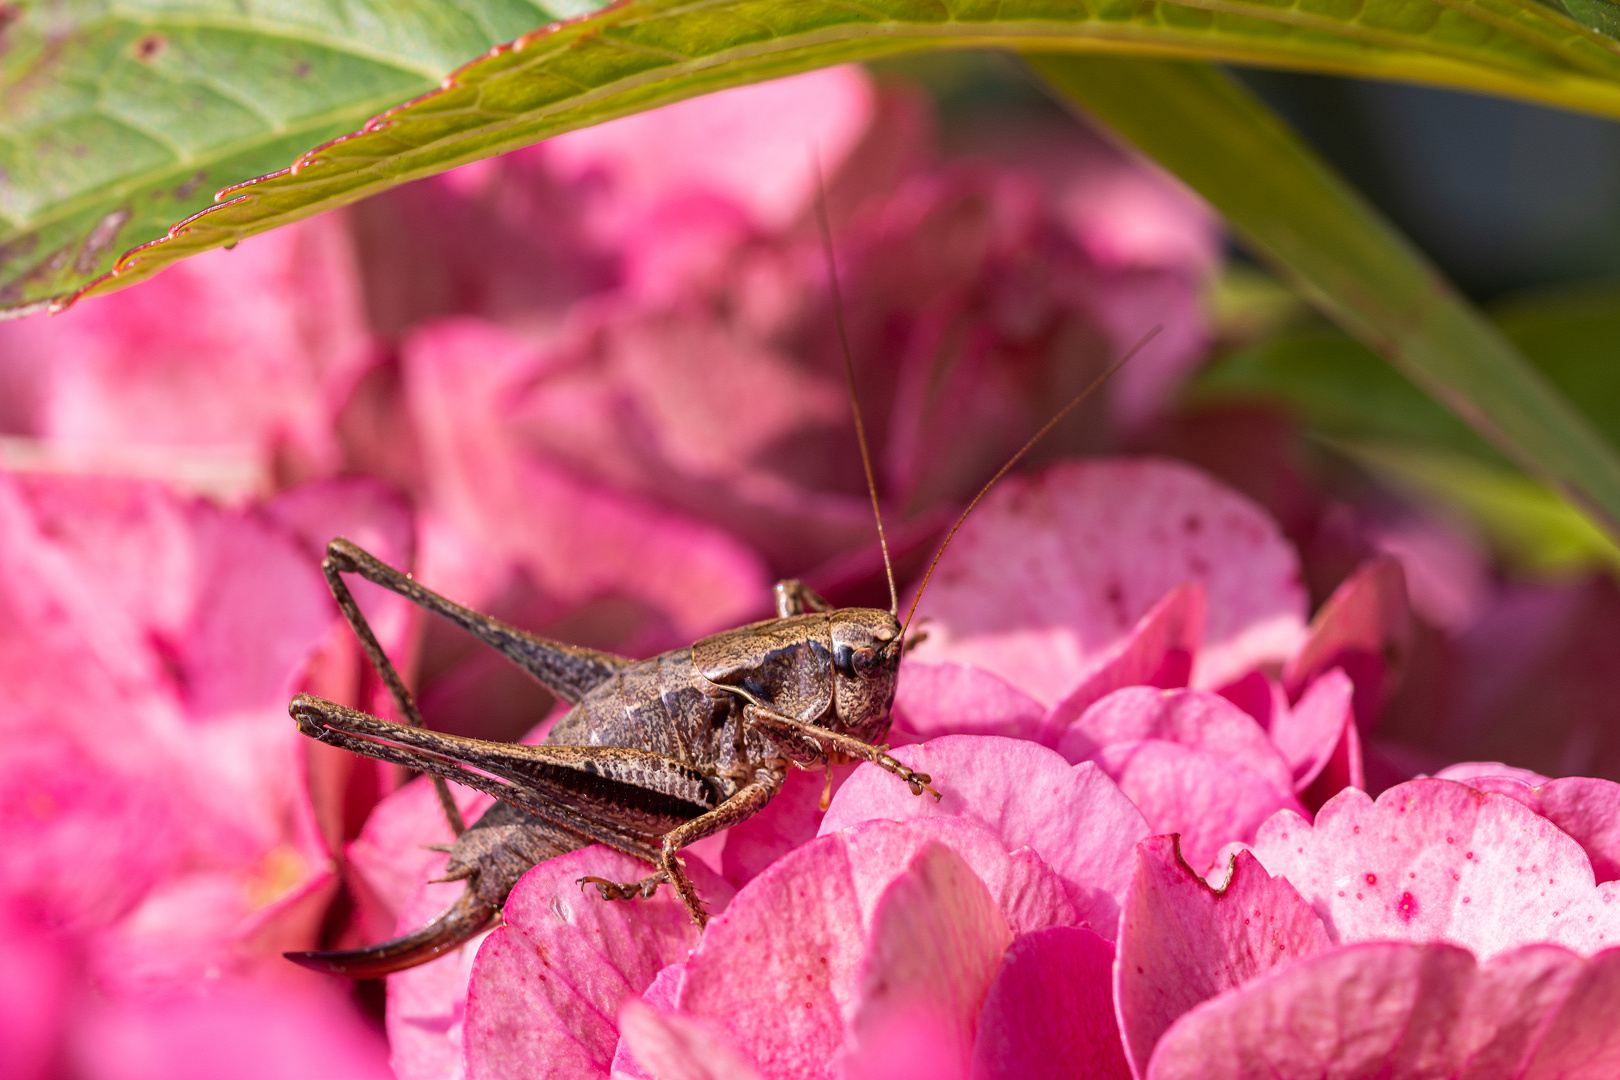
[1034,55,1620,533]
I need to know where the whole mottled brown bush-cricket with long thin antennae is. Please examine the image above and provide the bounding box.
[287,190,1157,978]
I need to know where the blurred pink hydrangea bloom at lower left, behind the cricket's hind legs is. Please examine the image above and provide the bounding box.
[0,476,408,1078]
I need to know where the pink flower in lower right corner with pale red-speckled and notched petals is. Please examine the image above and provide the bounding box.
[1116,780,1620,1080]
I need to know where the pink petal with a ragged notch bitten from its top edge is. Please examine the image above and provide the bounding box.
[1115,836,1330,1075]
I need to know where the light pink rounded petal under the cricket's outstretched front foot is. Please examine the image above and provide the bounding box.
[821,735,1149,938]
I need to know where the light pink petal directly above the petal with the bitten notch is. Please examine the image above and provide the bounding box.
[1094,738,1304,866]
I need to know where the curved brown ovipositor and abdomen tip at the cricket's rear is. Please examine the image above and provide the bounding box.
[285,801,588,978]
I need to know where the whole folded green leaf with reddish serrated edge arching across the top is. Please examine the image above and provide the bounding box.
[15,0,1620,308]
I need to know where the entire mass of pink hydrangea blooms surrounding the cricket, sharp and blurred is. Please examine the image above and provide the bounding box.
[0,70,1620,1080]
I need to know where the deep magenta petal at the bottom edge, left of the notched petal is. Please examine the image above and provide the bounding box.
[970,926,1131,1080]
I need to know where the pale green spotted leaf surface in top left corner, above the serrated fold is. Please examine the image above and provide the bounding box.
[0,0,599,313]
